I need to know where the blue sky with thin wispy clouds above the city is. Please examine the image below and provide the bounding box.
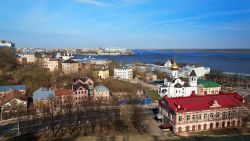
[0,0,250,49]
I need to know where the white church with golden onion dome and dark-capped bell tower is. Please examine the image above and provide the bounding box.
[158,61,197,97]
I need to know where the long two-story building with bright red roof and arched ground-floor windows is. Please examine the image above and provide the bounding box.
[158,93,245,133]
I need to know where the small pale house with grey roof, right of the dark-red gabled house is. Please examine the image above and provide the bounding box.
[94,85,109,101]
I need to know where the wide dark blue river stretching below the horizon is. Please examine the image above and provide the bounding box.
[76,50,250,74]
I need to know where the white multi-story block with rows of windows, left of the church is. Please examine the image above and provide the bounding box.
[114,66,133,79]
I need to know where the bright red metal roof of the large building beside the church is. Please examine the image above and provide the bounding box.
[159,93,244,112]
